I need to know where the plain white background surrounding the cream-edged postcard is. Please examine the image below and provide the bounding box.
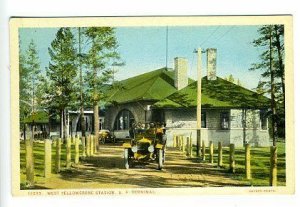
[0,0,300,207]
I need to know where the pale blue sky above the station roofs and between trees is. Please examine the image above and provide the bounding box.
[19,26,262,89]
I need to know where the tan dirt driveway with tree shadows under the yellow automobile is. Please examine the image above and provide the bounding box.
[36,143,245,189]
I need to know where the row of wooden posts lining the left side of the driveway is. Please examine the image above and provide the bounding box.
[25,135,97,186]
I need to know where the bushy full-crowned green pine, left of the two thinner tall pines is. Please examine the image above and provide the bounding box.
[45,27,77,138]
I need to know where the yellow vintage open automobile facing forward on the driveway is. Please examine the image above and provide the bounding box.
[123,125,166,170]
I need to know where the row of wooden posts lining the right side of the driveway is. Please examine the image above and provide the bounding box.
[173,136,277,186]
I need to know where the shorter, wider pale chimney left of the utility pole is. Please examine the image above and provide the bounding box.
[174,57,188,90]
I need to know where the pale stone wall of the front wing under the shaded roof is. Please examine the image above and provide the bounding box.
[165,109,270,147]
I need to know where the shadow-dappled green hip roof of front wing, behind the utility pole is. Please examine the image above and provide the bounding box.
[153,77,270,109]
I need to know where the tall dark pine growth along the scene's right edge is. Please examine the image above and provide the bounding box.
[250,25,285,145]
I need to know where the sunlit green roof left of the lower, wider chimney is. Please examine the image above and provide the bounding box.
[108,68,193,104]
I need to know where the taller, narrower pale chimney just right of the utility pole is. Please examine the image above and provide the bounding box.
[206,48,217,80]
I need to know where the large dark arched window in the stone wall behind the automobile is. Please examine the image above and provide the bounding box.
[114,109,134,130]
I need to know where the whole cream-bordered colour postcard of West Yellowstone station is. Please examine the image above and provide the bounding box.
[10,15,295,196]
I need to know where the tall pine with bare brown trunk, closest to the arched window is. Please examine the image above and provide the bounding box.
[85,27,120,147]
